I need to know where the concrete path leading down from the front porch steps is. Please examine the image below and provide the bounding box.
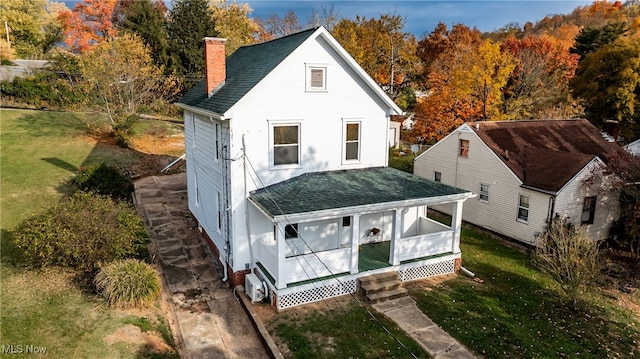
[373,297,475,359]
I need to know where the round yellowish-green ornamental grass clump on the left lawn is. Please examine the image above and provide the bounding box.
[95,259,160,308]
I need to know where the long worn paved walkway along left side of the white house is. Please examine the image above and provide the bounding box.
[135,173,269,359]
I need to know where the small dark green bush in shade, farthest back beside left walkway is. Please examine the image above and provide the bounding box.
[71,163,134,202]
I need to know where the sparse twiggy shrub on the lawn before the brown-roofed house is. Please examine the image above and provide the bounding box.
[533,218,604,308]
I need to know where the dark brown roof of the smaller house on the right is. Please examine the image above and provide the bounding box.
[470,119,619,192]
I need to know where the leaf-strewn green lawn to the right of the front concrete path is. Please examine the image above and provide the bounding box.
[410,229,640,358]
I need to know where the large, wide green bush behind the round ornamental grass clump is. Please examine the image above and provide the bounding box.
[13,192,148,273]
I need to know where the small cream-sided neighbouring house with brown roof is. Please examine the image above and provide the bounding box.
[414,120,619,244]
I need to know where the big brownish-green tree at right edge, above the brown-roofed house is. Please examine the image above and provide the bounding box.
[570,38,640,138]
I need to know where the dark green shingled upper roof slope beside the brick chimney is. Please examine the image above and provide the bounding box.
[178,29,316,115]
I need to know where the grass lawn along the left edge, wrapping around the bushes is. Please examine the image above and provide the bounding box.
[0,109,181,358]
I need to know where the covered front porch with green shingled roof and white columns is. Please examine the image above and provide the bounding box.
[249,168,472,310]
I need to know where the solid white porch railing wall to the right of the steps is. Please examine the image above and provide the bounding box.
[397,217,453,261]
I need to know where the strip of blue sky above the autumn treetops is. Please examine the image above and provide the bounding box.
[246,0,593,38]
